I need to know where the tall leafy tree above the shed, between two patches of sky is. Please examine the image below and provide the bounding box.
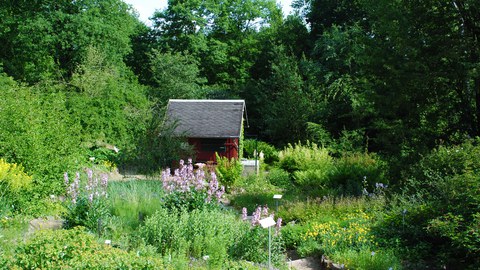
[154,0,282,87]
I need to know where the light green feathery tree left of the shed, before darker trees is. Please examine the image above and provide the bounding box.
[68,47,150,159]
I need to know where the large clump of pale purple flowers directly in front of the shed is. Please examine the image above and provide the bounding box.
[161,159,225,210]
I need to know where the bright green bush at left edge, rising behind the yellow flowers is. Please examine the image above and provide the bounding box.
[0,75,84,196]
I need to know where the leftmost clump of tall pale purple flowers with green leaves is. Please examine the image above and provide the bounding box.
[63,169,108,233]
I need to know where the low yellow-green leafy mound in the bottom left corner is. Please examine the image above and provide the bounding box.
[0,227,163,269]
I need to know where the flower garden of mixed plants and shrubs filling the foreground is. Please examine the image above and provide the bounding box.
[0,140,480,269]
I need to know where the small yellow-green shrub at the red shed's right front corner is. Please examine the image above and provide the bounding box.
[215,153,243,191]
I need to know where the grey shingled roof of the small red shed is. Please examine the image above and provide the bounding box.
[167,99,245,138]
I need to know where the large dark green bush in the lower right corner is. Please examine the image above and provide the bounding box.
[378,139,480,268]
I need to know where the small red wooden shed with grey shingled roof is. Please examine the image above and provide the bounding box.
[167,99,245,162]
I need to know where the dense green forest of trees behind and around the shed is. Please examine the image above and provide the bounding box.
[0,0,480,188]
